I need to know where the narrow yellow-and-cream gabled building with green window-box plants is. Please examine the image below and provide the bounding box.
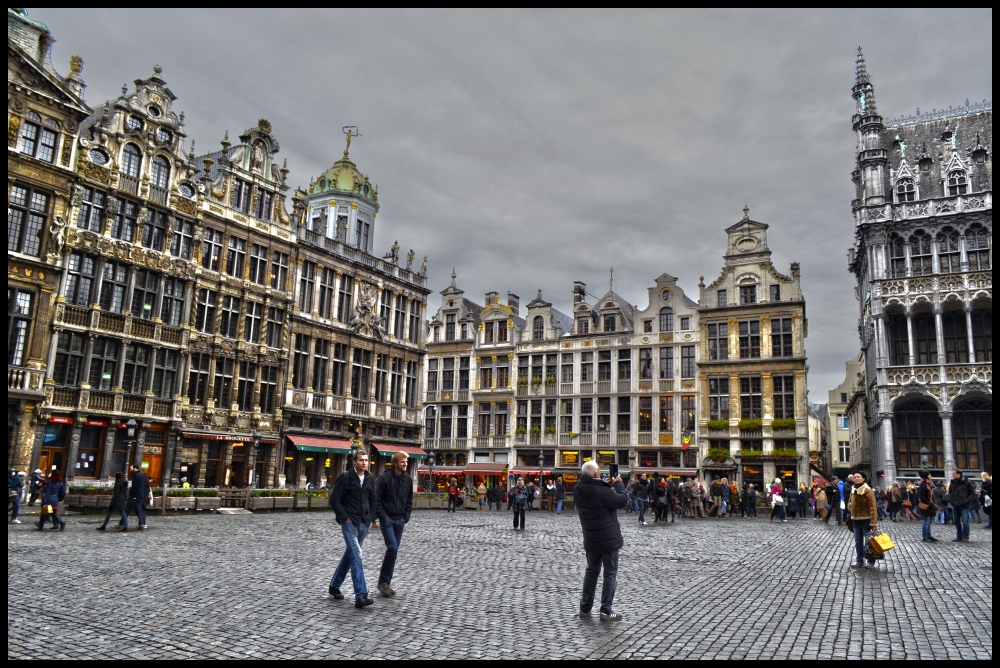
[698,208,811,488]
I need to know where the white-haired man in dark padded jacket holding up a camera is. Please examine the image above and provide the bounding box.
[573,461,628,621]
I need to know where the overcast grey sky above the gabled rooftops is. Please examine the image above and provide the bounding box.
[30,8,993,403]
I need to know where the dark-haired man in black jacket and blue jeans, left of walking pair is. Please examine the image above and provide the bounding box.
[330,448,376,608]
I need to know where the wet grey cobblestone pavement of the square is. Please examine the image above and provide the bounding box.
[7,510,993,659]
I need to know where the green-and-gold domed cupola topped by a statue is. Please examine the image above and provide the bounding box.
[302,126,379,253]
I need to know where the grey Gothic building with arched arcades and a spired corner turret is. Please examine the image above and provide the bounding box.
[848,49,993,484]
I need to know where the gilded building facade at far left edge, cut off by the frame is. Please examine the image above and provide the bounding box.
[7,9,90,470]
